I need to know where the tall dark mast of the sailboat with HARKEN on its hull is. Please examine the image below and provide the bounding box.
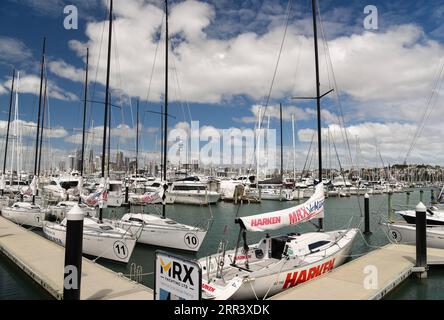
[311,0,323,230]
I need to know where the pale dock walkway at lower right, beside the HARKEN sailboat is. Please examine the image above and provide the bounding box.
[270,244,444,300]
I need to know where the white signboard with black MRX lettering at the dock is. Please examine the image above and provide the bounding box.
[154,251,202,300]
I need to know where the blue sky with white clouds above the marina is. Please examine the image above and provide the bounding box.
[0,0,444,170]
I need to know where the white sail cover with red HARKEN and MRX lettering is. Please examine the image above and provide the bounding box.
[239,183,324,232]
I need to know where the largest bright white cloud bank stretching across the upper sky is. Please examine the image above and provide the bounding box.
[43,0,444,119]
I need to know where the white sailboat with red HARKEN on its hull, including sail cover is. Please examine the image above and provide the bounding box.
[199,184,358,300]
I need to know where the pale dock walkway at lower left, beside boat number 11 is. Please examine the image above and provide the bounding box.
[0,217,153,300]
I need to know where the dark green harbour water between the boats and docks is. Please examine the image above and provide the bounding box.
[0,189,444,299]
